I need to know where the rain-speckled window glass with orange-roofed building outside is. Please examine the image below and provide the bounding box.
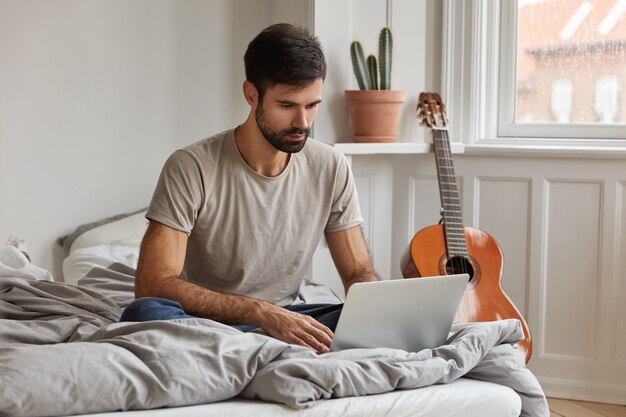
[515,0,626,124]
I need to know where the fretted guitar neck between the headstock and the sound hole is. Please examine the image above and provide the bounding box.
[432,128,467,258]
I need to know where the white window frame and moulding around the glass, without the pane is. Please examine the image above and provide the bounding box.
[442,0,626,150]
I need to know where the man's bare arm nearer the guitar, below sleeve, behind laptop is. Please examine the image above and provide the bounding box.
[326,226,380,293]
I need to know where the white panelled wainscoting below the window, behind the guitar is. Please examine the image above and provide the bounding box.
[314,154,626,404]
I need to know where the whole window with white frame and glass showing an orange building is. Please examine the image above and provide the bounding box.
[442,0,626,146]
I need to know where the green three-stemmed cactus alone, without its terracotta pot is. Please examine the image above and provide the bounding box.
[350,27,393,90]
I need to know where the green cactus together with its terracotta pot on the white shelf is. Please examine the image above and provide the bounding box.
[345,27,406,142]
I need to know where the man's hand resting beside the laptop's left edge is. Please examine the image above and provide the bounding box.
[260,305,333,353]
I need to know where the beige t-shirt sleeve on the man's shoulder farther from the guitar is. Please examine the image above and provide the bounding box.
[146,150,204,235]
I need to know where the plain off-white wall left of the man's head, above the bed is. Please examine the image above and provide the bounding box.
[0,0,269,277]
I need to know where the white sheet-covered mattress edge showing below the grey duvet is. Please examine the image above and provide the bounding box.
[72,378,521,417]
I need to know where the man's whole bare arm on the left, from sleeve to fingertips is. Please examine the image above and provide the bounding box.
[135,221,333,352]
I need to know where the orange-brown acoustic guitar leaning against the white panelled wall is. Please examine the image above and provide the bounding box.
[402,93,532,362]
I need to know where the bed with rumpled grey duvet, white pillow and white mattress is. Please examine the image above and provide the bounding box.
[0,211,549,417]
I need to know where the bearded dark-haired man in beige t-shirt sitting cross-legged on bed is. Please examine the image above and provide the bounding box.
[122,24,378,352]
